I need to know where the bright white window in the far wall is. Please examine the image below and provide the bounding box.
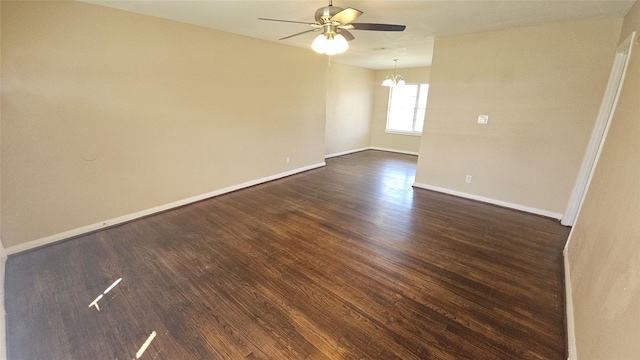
[387,84,429,134]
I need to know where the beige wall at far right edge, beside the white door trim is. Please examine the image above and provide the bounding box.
[567,2,640,360]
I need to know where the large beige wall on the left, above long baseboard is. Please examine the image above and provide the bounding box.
[1,1,326,249]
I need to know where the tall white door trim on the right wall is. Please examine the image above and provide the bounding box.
[561,32,636,226]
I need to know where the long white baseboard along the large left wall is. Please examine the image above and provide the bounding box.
[6,161,326,255]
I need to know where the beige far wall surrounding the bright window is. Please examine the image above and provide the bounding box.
[371,67,430,154]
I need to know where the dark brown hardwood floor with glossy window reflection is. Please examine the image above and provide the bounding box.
[6,151,569,360]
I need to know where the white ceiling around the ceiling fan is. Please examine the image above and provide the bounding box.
[85,0,634,69]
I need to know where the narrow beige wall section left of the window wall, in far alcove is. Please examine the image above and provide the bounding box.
[325,62,375,155]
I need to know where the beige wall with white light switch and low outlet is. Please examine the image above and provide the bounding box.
[416,19,622,216]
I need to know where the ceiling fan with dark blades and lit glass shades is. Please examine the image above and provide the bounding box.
[258,0,406,55]
